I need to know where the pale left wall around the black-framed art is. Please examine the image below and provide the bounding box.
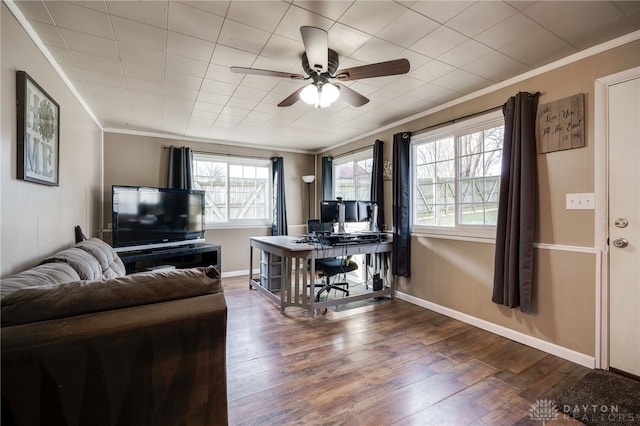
[0,4,103,277]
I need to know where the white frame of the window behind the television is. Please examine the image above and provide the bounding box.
[193,153,273,229]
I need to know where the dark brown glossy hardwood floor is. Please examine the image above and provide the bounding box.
[224,276,589,426]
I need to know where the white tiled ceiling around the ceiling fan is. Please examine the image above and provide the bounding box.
[8,0,640,151]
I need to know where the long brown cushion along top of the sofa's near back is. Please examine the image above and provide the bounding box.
[0,266,222,327]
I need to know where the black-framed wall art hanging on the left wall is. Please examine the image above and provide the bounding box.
[16,71,60,186]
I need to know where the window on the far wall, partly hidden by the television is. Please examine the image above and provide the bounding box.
[193,154,271,226]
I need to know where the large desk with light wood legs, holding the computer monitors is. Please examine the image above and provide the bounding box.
[249,235,395,316]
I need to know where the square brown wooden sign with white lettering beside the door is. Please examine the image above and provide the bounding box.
[536,93,585,154]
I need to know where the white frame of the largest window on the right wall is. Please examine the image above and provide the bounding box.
[410,110,504,242]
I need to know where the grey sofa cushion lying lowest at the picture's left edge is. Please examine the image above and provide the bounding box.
[0,263,80,297]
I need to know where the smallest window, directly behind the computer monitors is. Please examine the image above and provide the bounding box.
[333,150,373,201]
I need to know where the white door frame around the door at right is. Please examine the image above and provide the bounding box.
[594,67,640,370]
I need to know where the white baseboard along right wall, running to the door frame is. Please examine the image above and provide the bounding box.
[396,291,595,369]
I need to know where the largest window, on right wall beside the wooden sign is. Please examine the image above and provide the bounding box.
[411,111,504,237]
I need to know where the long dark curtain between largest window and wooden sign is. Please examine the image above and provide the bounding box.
[491,92,539,314]
